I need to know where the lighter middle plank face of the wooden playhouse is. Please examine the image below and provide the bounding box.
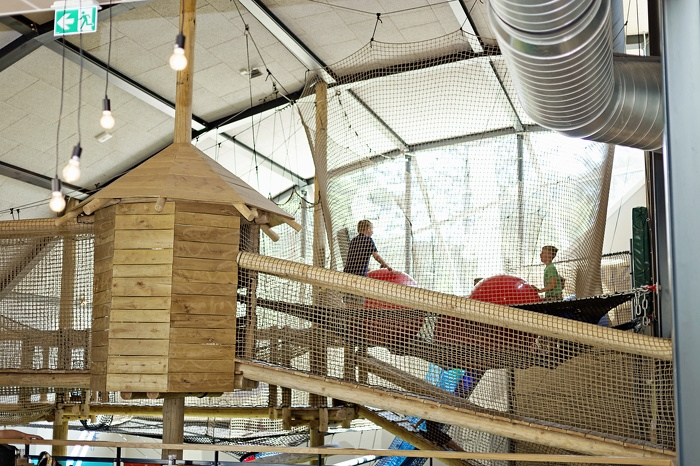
[104,202,175,392]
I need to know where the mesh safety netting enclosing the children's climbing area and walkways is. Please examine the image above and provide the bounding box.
[0,31,675,464]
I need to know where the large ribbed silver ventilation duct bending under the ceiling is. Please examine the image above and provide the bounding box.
[489,0,664,150]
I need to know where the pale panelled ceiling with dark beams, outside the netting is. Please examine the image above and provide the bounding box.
[0,0,646,220]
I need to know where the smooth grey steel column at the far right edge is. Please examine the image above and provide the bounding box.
[662,0,700,460]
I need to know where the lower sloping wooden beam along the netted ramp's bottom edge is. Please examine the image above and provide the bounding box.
[237,362,672,458]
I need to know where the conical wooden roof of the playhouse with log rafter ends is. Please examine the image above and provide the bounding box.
[57,143,301,240]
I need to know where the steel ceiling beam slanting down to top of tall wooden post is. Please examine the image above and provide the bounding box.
[239,0,335,84]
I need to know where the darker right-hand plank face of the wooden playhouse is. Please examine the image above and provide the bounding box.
[168,201,240,392]
